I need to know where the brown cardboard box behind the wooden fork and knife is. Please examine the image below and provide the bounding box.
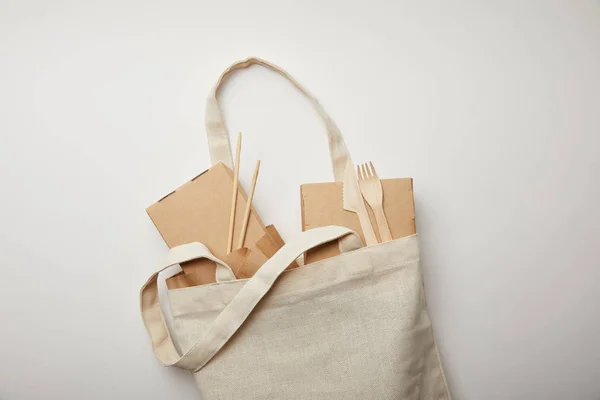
[300,178,417,264]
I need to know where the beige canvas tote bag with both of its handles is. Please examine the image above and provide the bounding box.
[141,59,450,400]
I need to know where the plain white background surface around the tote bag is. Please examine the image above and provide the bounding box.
[0,0,600,400]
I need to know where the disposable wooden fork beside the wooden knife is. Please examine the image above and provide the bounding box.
[356,161,392,242]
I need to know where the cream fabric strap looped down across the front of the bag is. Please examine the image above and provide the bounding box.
[140,226,362,372]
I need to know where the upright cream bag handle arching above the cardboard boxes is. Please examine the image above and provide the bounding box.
[206,57,352,182]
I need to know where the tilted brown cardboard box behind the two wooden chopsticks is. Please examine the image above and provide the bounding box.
[146,163,267,289]
